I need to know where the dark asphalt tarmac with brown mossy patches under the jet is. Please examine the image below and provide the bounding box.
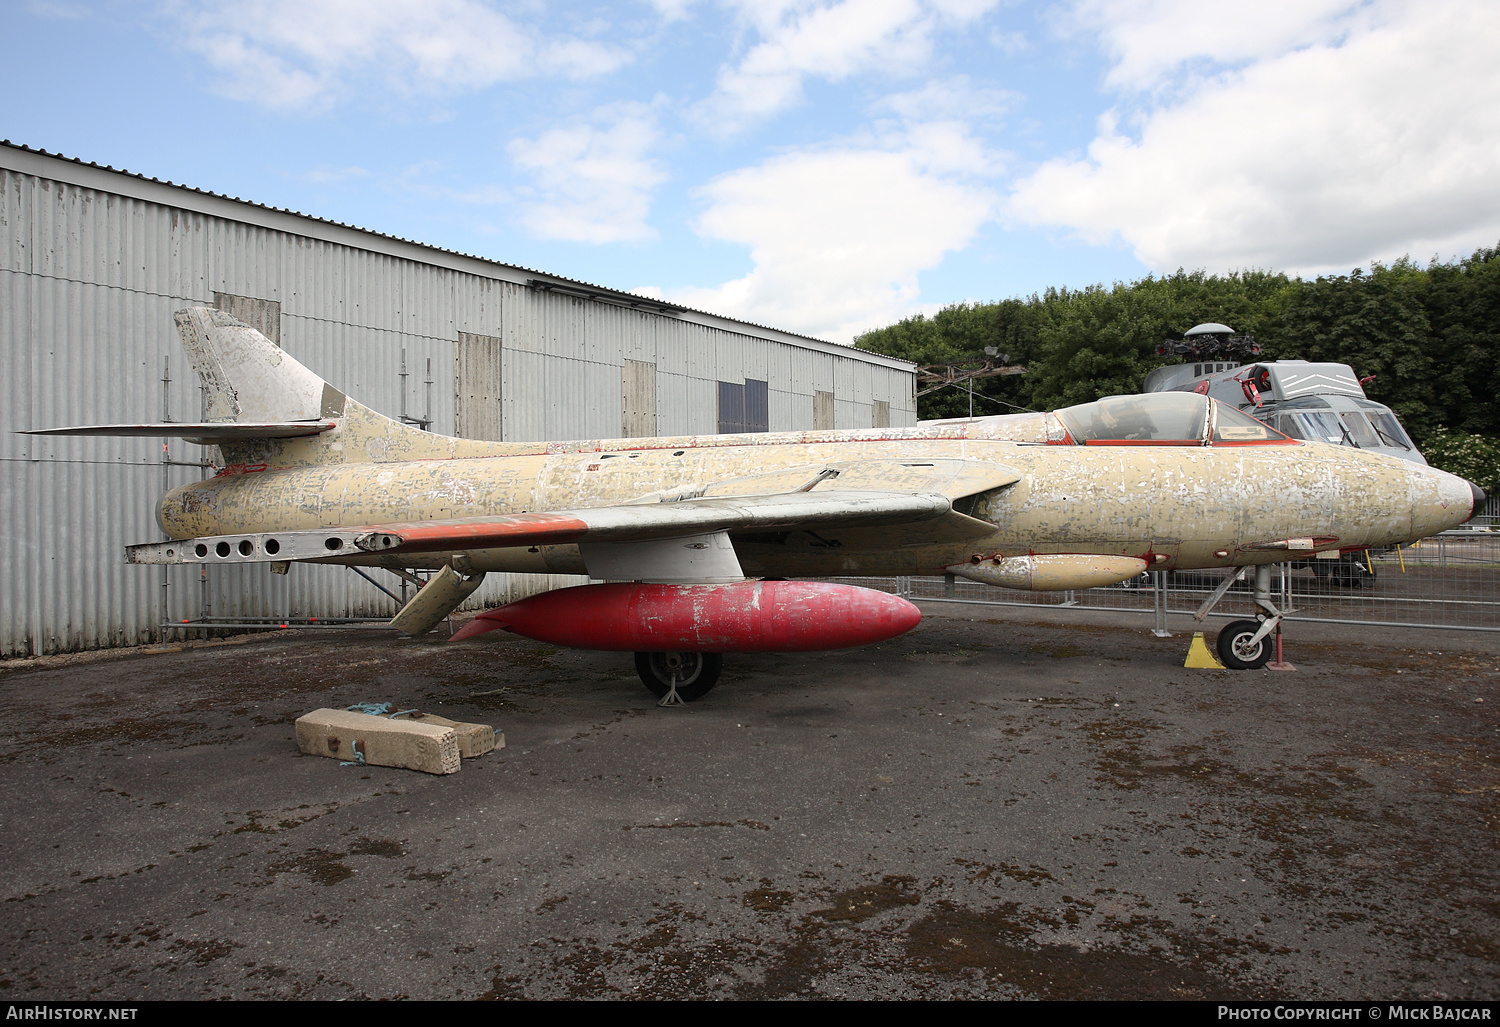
[0,603,1500,1000]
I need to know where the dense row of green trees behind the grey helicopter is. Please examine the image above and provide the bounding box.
[855,247,1500,447]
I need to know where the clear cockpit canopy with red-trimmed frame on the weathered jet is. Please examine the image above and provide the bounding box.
[1056,393,1296,445]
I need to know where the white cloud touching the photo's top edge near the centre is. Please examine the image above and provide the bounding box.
[696,0,995,133]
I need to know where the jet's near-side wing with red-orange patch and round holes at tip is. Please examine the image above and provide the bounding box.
[126,492,995,564]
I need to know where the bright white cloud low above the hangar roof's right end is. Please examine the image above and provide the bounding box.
[671,126,995,342]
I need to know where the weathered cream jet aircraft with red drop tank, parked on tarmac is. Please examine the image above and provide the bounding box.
[29,307,1484,700]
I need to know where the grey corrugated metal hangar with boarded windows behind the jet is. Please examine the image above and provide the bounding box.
[0,142,917,655]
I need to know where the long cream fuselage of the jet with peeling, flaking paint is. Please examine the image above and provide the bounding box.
[159,400,1472,577]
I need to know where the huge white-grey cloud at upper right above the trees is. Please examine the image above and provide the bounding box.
[1010,0,1500,273]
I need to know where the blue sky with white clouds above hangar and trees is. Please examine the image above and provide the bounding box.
[0,0,1500,342]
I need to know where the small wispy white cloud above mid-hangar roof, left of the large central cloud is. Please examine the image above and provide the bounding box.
[509,103,666,243]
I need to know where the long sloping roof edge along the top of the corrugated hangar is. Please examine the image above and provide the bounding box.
[0,139,917,372]
